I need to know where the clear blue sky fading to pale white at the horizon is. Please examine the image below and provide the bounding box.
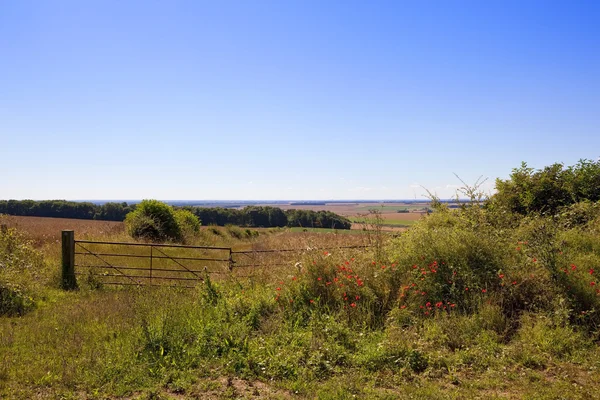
[0,0,600,200]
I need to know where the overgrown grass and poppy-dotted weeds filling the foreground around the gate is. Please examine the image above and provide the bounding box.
[0,211,600,399]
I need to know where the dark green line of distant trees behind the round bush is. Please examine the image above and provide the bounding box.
[0,200,352,229]
